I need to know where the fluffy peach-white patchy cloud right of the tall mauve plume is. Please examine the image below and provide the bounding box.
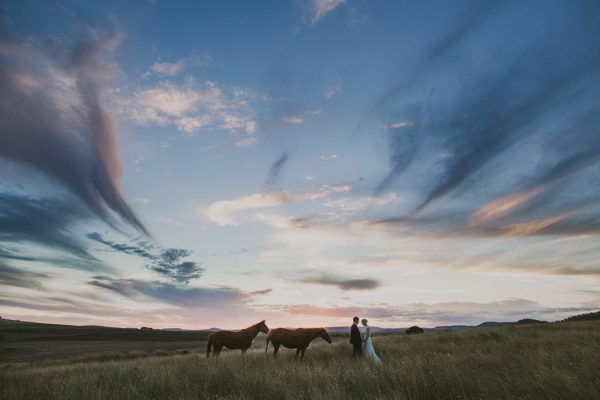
[118,79,256,135]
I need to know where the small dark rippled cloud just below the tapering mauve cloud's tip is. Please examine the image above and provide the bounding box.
[86,232,205,285]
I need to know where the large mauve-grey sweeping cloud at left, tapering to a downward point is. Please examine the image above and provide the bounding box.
[0,30,146,233]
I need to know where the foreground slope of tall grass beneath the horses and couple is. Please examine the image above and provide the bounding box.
[0,322,600,400]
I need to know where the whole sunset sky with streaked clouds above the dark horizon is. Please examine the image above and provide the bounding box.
[0,0,600,329]
